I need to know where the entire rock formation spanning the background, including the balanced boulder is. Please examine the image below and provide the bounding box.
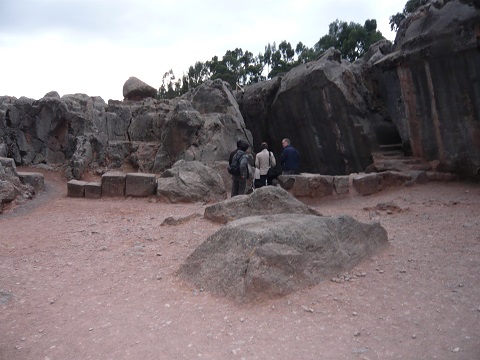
[0,0,480,180]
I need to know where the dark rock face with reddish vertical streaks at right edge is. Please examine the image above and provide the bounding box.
[374,0,480,179]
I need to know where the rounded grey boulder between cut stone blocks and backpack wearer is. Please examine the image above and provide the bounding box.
[157,160,227,203]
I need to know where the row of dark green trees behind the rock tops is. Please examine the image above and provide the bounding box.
[158,17,386,99]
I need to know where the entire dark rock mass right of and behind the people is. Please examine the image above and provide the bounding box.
[237,0,480,180]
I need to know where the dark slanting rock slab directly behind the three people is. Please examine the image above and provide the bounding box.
[237,42,395,175]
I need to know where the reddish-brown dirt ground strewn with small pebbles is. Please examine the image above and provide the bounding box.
[0,169,480,360]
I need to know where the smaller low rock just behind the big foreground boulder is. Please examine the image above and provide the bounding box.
[204,186,320,224]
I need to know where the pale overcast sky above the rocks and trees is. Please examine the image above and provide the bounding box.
[0,0,406,101]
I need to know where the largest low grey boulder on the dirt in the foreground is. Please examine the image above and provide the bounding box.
[179,214,388,302]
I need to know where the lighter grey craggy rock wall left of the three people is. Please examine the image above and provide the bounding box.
[0,80,252,179]
